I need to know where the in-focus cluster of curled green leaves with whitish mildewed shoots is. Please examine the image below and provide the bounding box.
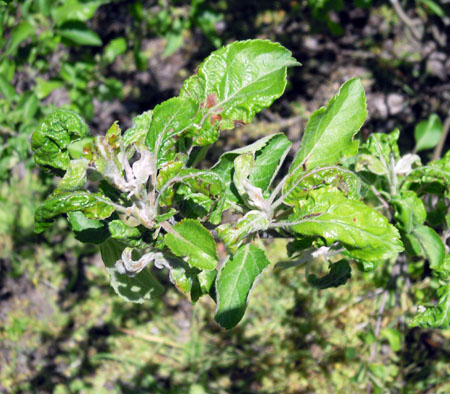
[32,40,449,329]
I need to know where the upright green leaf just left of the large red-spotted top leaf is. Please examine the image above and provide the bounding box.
[146,97,198,167]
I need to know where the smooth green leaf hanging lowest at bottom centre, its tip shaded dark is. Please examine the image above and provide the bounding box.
[215,244,270,329]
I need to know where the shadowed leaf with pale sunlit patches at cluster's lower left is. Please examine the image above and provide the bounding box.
[100,239,164,304]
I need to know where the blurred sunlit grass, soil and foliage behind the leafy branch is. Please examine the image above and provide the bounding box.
[0,0,450,394]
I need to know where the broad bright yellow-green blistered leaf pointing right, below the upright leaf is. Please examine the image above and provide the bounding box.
[282,188,403,261]
